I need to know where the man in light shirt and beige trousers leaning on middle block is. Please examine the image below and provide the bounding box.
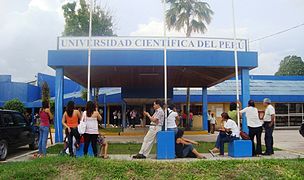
[133,100,165,159]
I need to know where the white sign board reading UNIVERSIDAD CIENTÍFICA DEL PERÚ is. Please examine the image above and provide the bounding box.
[58,36,247,51]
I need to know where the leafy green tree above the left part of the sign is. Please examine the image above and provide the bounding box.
[62,0,113,36]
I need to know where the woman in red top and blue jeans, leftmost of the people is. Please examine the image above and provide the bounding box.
[38,102,53,157]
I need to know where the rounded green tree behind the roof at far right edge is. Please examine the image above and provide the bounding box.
[275,55,304,76]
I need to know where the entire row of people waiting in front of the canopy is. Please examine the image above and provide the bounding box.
[38,98,275,159]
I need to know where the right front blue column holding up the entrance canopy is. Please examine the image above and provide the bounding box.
[241,69,250,133]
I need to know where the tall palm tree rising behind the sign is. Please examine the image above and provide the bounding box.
[166,0,214,129]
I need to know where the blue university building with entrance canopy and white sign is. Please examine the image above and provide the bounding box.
[0,37,304,141]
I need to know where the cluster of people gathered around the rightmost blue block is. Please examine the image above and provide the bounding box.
[210,98,275,156]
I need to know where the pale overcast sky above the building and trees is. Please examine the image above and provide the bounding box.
[0,0,304,82]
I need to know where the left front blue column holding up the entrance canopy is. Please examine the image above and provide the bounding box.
[54,67,64,143]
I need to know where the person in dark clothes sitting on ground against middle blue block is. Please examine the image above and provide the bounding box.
[175,129,205,159]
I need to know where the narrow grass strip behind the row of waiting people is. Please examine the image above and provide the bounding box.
[47,142,279,154]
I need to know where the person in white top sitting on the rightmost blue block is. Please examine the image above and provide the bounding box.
[209,112,240,156]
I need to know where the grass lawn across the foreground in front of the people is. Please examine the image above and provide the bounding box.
[0,156,304,180]
